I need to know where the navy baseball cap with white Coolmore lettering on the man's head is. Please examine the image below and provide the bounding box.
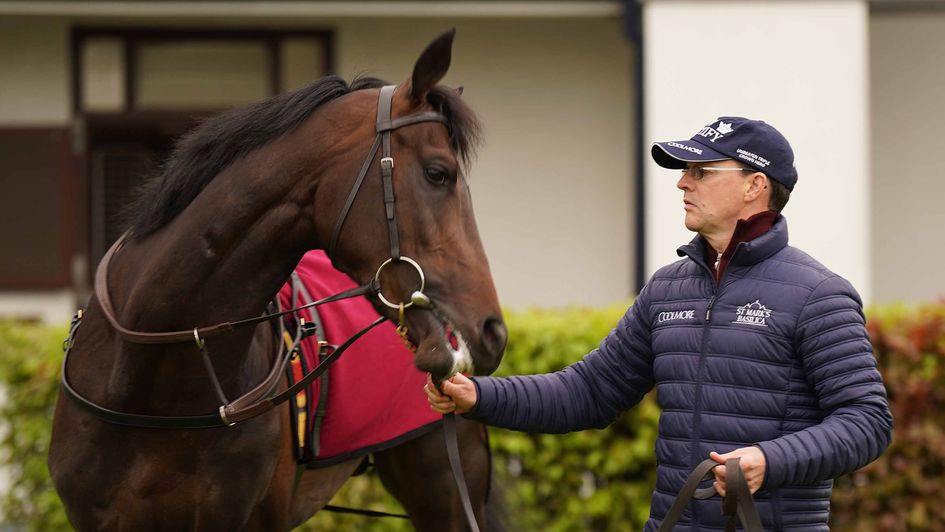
[650,116,797,190]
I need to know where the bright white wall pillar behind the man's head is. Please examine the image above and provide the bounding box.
[644,0,872,299]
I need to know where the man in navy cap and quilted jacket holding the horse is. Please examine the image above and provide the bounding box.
[426,117,892,531]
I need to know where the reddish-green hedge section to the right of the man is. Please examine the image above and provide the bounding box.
[831,303,945,532]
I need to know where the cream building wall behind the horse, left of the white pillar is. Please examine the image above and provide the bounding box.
[0,13,634,316]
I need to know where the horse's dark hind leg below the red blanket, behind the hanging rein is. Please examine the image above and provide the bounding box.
[374,419,491,532]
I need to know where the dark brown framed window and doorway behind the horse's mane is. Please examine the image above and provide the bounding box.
[73,28,331,267]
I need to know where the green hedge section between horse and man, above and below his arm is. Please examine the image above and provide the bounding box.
[490,305,659,531]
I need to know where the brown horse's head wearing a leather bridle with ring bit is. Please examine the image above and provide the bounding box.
[316,31,507,380]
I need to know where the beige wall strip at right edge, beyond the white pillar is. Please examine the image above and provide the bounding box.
[870,11,945,301]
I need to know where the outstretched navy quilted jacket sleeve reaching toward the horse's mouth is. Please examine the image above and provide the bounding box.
[466,288,653,433]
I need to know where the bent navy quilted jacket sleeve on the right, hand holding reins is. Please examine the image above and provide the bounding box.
[758,276,892,489]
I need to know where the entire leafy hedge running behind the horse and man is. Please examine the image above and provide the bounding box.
[0,304,945,532]
